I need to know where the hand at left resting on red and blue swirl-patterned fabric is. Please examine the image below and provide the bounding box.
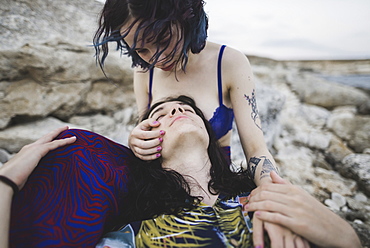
[0,127,76,189]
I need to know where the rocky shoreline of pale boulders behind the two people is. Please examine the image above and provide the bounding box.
[0,0,370,247]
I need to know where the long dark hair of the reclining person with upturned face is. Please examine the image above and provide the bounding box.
[122,96,255,224]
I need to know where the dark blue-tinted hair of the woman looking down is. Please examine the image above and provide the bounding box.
[94,0,208,70]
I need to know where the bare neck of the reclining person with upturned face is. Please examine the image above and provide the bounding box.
[162,147,218,206]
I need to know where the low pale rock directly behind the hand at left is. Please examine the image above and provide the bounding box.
[0,117,77,153]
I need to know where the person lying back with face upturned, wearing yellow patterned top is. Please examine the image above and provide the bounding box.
[0,97,361,248]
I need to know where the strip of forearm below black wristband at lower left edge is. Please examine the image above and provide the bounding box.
[0,181,14,247]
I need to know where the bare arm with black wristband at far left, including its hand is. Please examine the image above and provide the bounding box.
[0,127,76,247]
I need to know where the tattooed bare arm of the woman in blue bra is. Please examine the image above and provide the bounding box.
[222,46,277,186]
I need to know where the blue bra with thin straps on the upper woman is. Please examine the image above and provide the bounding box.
[148,45,234,139]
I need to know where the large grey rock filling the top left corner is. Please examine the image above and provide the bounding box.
[0,0,103,50]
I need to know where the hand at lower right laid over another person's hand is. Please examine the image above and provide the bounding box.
[245,172,361,247]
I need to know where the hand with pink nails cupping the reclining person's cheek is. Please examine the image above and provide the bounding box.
[128,119,165,160]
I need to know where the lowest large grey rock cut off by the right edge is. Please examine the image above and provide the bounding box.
[338,154,370,197]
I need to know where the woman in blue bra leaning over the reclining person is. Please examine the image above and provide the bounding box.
[94,0,285,245]
